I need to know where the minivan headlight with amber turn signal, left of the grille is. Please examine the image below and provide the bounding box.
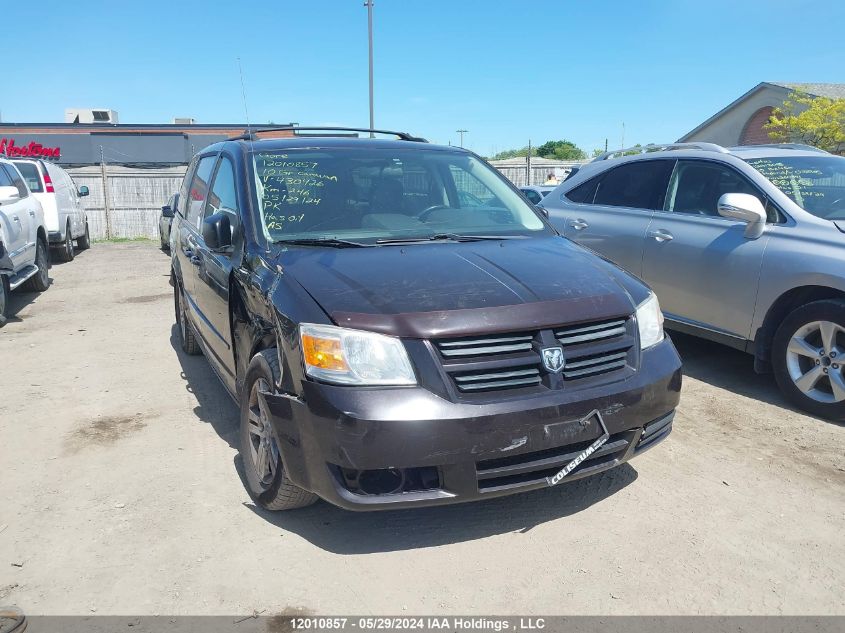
[299,323,417,385]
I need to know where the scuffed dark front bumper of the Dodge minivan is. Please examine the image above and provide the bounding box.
[267,338,681,510]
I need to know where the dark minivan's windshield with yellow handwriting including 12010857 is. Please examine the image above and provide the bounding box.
[252,146,551,245]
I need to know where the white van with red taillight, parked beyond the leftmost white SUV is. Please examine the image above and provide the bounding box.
[12,159,91,262]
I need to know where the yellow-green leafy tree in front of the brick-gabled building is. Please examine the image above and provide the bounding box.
[763,92,845,154]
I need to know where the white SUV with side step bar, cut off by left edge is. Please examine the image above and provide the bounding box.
[0,159,50,326]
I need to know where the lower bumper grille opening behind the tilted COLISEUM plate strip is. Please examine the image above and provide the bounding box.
[475,430,637,492]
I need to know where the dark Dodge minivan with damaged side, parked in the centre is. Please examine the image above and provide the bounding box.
[171,128,681,510]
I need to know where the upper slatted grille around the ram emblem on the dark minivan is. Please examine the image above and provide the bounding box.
[432,317,638,399]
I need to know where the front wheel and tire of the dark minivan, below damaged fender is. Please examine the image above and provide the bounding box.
[240,349,318,511]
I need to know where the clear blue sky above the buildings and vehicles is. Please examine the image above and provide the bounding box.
[0,0,845,155]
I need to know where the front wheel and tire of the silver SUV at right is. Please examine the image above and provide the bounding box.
[772,299,845,421]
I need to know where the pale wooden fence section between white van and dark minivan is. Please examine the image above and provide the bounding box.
[67,165,187,239]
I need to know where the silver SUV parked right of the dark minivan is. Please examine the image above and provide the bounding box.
[542,143,845,420]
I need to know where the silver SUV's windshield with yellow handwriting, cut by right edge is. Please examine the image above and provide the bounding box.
[746,155,845,220]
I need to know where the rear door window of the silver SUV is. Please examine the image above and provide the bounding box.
[593,160,674,210]
